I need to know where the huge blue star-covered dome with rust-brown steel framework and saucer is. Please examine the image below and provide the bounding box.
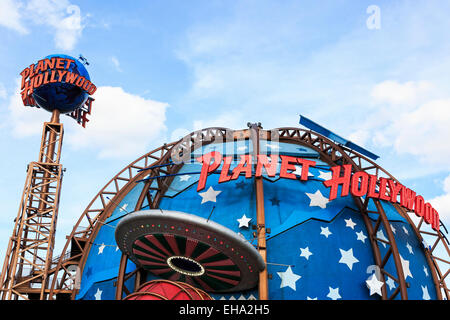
[51,128,449,300]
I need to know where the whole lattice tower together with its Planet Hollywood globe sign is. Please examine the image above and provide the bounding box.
[0,55,96,300]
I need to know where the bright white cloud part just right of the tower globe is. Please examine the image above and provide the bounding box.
[67,87,168,158]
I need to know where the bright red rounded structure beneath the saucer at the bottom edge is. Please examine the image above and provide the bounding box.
[124,279,212,300]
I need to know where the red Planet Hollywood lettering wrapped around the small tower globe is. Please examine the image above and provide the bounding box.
[20,57,97,105]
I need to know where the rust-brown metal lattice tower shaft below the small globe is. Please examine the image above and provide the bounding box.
[0,110,63,300]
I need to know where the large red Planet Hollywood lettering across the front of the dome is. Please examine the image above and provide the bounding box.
[196,151,439,231]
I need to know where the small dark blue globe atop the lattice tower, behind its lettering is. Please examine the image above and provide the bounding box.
[32,54,90,113]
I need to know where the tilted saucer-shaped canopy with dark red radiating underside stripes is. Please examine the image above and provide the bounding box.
[115,210,265,292]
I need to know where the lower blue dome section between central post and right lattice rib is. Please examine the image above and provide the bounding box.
[267,209,378,300]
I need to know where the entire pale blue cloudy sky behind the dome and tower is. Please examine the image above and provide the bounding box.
[0,0,450,288]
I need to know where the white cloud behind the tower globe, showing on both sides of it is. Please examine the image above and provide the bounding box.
[5,79,168,158]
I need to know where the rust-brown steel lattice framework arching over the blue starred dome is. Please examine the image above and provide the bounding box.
[27,127,450,300]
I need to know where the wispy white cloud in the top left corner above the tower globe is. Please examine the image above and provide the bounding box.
[0,0,84,50]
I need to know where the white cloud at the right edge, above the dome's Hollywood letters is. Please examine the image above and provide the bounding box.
[350,80,450,173]
